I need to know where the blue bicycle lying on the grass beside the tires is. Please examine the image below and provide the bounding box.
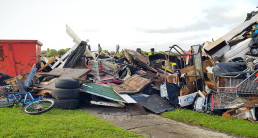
[0,91,54,115]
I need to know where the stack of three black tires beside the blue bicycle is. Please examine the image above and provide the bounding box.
[52,79,80,110]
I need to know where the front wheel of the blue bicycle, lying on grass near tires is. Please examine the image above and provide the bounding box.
[23,98,54,115]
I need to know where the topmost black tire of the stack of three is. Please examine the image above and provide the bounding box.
[55,79,80,89]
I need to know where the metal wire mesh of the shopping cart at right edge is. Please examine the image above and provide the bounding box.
[211,77,258,109]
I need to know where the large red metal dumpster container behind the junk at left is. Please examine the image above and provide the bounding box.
[0,40,42,77]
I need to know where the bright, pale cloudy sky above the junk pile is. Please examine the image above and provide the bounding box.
[0,0,258,51]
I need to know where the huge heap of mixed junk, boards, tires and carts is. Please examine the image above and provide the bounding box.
[0,12,258,122]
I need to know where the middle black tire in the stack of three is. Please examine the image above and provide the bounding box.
[52,88,80,99]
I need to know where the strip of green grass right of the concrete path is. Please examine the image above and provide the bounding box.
[162,109,258,137]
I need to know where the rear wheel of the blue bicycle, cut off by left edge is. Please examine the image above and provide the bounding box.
[0,92,22,107]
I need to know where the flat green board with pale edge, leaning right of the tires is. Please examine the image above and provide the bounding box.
[81,83,125,102]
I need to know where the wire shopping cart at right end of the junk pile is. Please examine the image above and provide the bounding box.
[211,65,258,110]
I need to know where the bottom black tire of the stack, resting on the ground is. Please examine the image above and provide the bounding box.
[54,99,80,110]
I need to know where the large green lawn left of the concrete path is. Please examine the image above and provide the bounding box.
[0,106,140,137]
